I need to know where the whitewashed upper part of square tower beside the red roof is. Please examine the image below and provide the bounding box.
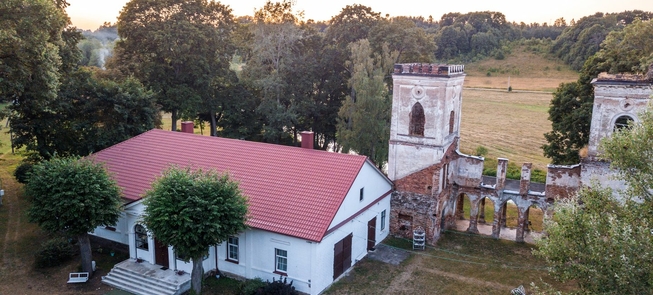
[388,64,465,180]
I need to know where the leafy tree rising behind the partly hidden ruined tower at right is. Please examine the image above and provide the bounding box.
[542,21,653,164]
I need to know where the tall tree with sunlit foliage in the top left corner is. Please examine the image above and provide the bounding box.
[0,0,81,155]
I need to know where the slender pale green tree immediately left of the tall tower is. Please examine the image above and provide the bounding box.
[337,39,397,168]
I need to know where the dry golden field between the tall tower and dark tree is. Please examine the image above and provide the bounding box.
[460,49,578,169]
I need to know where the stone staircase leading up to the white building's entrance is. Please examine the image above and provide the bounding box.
[102,260,190,295]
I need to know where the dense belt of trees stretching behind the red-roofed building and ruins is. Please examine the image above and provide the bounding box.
[0,0,653,166]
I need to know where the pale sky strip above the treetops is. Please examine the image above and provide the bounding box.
[67,0,653,30]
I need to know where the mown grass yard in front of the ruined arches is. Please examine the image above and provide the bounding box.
[325,236,572,295]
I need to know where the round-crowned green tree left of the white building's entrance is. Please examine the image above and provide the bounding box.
[25,158,121,273]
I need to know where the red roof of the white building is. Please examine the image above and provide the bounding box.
[92,129,366,242]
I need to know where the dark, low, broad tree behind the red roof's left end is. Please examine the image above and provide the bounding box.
[9,68,160,159]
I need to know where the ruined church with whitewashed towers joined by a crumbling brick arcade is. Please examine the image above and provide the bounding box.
[388,64,653,244]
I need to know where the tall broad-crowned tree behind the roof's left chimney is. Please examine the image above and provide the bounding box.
[115,0,234,130]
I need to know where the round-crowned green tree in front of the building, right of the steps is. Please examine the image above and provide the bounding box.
[143,167,247,294]
